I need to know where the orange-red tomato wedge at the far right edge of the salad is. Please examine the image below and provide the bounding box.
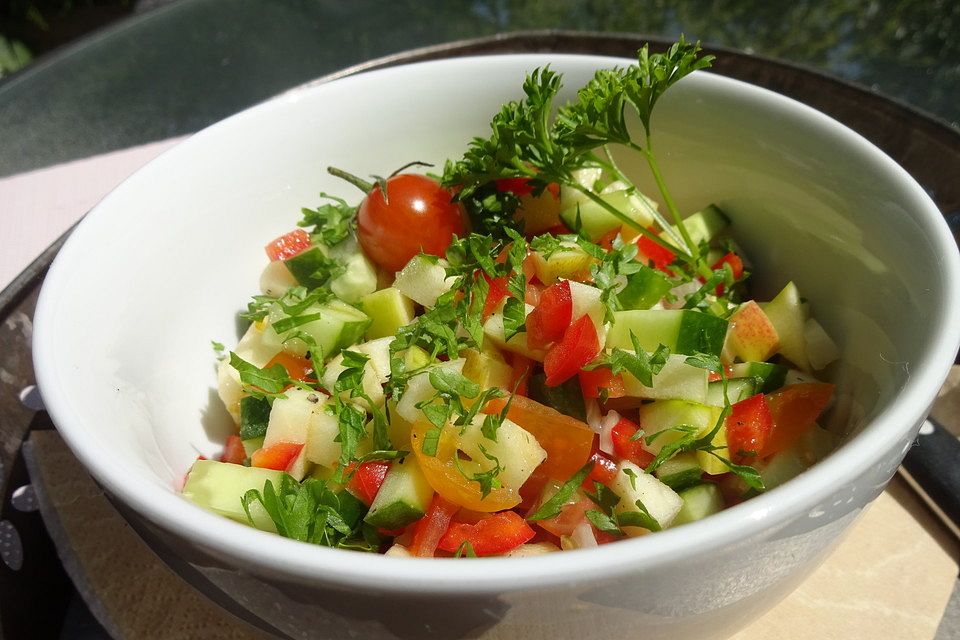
[760,382,833,458]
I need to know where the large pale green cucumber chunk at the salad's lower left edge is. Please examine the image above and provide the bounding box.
[182,460,283,533]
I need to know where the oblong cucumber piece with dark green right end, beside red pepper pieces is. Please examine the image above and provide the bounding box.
[606,309,727,355]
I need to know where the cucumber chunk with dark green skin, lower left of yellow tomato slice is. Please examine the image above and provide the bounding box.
[363,455,433,530]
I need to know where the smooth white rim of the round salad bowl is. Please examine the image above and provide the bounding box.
[33,53,960,595]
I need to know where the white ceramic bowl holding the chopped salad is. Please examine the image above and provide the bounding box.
[34,55,960,639]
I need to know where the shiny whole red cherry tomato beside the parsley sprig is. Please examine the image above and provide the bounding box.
[357,173,464,271]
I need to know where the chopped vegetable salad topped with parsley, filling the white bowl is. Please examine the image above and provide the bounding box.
[182,40,839,557]
